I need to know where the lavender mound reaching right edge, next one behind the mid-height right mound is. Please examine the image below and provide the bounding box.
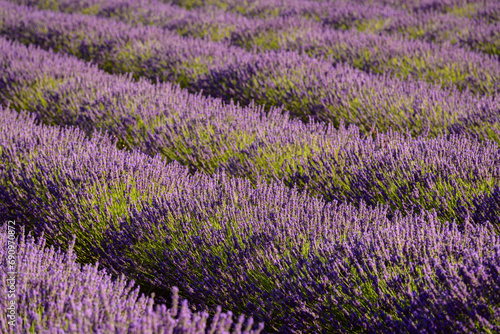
[195,48,500,141]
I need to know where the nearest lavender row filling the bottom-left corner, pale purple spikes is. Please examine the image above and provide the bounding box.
[0,224,262,334]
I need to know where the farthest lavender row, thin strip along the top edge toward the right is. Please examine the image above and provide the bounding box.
[163,0,500,29]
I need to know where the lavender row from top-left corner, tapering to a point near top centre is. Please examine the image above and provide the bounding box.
[0,1,246,86]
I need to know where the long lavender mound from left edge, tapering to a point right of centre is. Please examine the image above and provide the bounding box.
[0,39,336,183]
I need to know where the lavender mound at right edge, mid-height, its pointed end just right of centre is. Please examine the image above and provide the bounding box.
[281,132,500,226]
